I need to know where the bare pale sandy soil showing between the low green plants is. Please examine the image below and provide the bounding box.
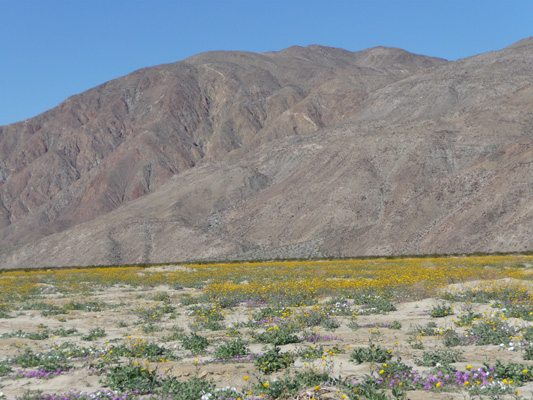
[0,282,533,400]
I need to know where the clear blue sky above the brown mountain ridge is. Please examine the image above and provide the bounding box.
[0,0,533,125]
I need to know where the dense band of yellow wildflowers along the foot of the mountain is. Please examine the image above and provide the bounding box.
[0,256,533,312]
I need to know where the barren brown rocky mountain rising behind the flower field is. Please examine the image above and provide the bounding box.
[0,38,533,268]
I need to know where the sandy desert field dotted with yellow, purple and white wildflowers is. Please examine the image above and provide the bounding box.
[0,255,533,400]
